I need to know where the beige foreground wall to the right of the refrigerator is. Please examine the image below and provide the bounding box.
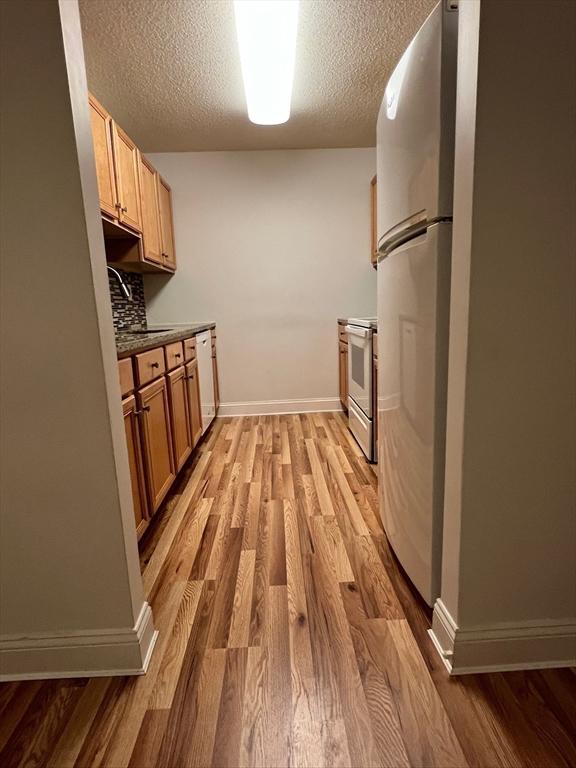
[442,0,576,629]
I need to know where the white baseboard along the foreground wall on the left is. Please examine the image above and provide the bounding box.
[0,602,158,682]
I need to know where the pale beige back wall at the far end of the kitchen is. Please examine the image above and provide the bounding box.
[145,149,376,411]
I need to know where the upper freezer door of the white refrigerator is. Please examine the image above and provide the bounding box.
[377,3,458,251]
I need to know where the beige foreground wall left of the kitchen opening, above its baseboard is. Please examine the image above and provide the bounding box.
[0,0,153,674]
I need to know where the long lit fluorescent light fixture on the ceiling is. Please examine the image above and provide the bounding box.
[234,0,299,125]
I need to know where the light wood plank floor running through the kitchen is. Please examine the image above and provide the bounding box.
[0,414,576,768]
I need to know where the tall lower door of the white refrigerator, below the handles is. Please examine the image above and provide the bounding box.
[378,224,452,605]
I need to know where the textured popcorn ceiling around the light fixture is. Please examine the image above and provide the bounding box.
[80,0,437,152]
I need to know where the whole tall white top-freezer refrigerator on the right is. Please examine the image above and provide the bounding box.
[377,0,458,605]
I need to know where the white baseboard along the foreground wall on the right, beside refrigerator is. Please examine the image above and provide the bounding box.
[429,600,576,675]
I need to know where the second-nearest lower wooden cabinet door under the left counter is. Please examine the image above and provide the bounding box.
[138,376,176,513]
